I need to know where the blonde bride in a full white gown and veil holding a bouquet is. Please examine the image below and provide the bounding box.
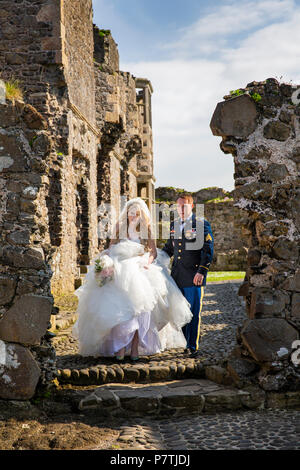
[72,198,192,361]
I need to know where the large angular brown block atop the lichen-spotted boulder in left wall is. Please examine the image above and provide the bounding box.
[0,295,53,345]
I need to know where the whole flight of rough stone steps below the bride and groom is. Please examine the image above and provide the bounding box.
[52,288,300,417]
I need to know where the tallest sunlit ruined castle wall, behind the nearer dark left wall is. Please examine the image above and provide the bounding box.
[0,0,99,293]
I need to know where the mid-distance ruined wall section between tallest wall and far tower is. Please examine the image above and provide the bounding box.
[94,26,149,222]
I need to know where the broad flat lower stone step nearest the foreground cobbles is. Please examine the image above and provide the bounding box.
[75,379,265,417]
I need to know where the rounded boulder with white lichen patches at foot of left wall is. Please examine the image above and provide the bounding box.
[0,340,41,400]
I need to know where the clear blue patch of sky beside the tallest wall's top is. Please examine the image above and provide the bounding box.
[93,0,213,62]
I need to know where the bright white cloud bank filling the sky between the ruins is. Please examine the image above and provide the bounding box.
[122,0,300,191]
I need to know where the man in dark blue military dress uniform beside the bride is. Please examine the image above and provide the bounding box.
[163,193,214,358]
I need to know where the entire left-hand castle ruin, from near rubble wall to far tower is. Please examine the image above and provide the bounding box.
[0,0,155,400]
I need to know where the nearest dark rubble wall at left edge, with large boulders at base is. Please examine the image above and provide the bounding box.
[0,97,55,399]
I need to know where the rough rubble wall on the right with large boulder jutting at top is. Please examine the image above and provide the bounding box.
[211,79,300,391]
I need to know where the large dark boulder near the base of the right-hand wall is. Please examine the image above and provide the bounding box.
[241,318,299,362]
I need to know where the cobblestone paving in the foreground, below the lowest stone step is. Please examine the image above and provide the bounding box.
[110,410,300,450]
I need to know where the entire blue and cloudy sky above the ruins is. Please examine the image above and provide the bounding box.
[93,0,300,191]
